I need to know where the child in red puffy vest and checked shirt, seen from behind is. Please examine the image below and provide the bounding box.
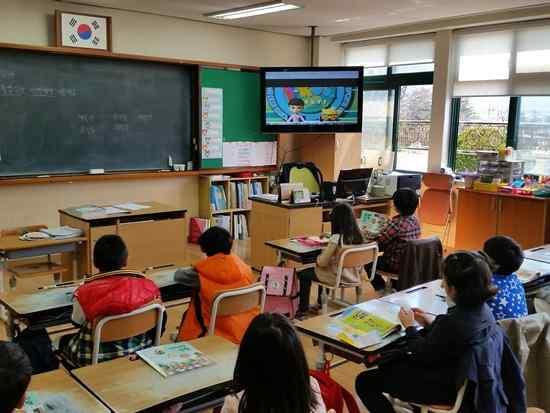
[59,235,160,366]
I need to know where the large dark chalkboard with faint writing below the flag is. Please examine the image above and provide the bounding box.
[0,49,198,177]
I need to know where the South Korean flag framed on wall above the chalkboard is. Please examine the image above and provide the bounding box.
[61,13,107,50]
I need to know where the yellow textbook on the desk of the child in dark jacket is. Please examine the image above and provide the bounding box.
[333,307,401,348]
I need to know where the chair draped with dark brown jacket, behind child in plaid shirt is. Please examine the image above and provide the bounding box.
[378,237,443,292]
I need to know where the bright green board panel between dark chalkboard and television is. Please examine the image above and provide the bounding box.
[200,68,276,169]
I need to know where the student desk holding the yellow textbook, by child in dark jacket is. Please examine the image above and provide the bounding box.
[296,280,447,363]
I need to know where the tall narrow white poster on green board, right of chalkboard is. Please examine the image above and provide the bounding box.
[201,87,223,159]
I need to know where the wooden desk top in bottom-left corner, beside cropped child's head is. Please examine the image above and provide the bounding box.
[29,370,109,413]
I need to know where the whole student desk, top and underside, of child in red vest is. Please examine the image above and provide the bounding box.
[0,269,192,337]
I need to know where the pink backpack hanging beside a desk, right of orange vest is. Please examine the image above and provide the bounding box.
[261,267,300,319]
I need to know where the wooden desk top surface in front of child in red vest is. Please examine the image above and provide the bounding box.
[0,268,181,316]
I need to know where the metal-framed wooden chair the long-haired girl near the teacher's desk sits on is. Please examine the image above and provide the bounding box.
[315,242,378,314]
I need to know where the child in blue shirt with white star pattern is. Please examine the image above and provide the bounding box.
[483,235,527,320]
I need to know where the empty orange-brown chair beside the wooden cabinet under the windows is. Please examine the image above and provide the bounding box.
[418,173,453,249]
